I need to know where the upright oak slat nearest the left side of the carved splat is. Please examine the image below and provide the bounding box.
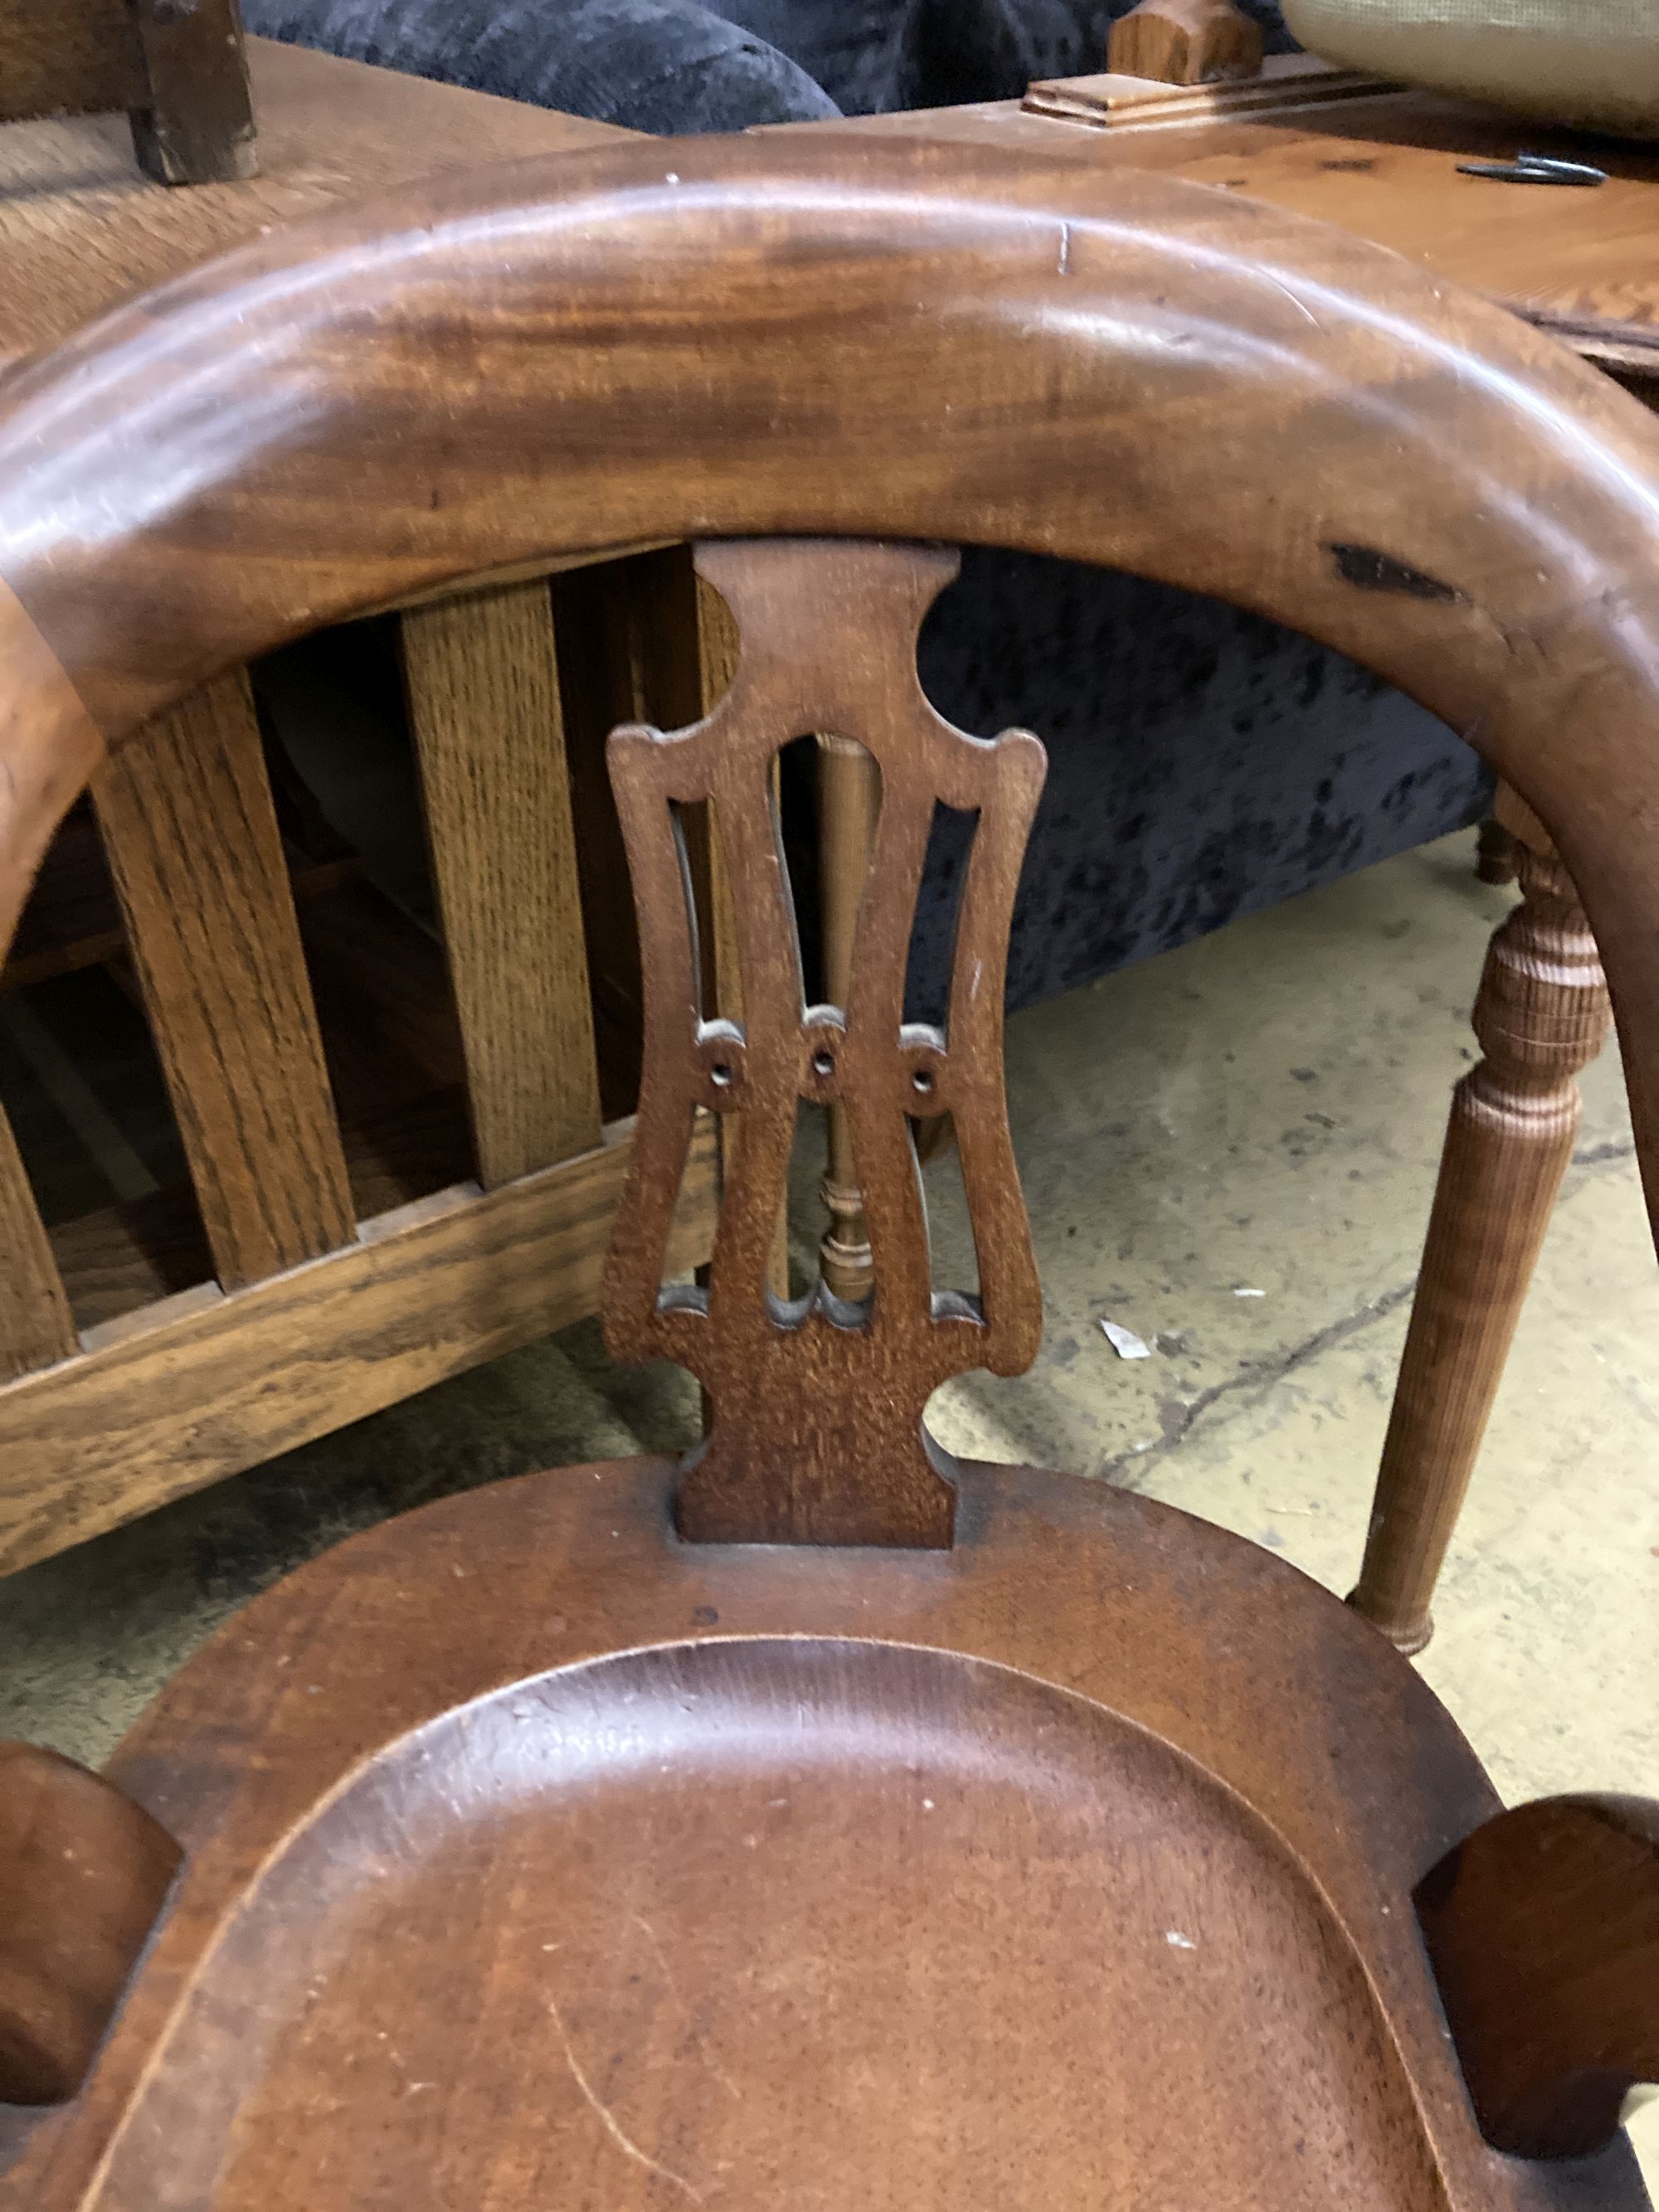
[402,580,600,1190]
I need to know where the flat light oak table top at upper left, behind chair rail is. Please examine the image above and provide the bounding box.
[0,37,630,365]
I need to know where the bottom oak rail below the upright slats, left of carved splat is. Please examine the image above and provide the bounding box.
[0,1115,714,1573]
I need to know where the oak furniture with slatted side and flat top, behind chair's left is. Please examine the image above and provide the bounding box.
[0,39,730,1568]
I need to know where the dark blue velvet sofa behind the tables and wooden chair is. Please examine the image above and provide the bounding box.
[243,0,1489,1013]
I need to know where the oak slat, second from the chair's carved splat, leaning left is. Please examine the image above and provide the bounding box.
[93,673,356,1290]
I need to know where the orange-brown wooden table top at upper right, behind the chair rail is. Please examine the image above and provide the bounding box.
[831,90,1659,378]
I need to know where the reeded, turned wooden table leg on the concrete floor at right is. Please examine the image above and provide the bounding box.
[1350,792,1608,1652]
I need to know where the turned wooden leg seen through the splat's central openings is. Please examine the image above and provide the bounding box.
[819,737,880,1300]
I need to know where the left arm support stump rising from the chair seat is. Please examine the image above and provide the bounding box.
[0,1743,182,2103]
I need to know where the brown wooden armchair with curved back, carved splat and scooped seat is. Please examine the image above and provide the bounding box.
[0,139,1659,2212]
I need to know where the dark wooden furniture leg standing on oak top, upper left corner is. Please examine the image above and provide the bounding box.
[0,0,259,183]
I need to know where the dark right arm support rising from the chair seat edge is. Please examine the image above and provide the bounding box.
[1416,1796,1659,2159]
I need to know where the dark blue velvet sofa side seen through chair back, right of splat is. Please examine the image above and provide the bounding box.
[909,548,1491,1019]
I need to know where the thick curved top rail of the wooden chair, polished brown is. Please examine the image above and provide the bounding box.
[0,133,1659,1256]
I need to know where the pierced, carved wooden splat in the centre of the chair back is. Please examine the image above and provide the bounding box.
[606,540,1044,1546]
